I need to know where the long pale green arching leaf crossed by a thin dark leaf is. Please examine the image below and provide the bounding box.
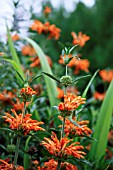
[24,37,58,106]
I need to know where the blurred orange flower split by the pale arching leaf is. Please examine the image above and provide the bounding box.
[30,55,52,67]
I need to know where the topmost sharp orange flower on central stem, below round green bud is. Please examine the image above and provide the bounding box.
[58,94,86,111]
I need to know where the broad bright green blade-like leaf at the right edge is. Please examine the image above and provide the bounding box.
[89,81,113,164]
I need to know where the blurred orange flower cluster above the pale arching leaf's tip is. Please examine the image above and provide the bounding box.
[30,20,61,40]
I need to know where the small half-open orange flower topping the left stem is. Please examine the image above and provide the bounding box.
[20,86,36,102]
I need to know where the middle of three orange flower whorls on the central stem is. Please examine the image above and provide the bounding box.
[59,116,92,136]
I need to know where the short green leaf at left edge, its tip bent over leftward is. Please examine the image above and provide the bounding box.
[3,59,25,83]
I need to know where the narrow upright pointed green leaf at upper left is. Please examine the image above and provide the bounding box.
[6,25,24,79]
